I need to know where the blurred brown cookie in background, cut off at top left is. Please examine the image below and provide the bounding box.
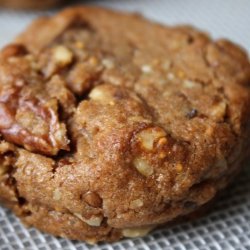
[0,0,63,9]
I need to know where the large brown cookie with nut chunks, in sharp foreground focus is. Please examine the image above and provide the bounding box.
[0,8,250,243]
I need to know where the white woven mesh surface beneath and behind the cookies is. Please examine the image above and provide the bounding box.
[0,0,250,250]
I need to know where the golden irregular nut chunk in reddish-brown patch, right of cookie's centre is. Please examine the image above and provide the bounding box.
[137,128,166,150]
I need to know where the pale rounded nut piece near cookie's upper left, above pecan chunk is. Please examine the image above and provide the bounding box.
[53,45,73,66]
